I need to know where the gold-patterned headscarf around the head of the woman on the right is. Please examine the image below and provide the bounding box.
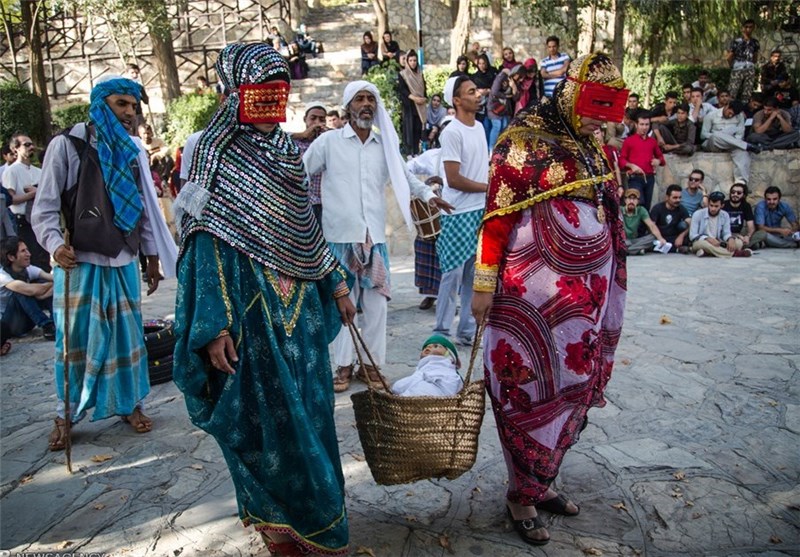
[553,52,627,130]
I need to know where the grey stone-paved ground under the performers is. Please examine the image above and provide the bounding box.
[0,250,800,557]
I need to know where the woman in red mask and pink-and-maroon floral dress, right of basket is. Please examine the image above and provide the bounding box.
[472,53,627,545]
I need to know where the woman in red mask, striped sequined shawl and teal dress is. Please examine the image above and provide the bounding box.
[174,44,355,555]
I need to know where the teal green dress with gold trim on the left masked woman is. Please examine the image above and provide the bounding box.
[174,231,348,555]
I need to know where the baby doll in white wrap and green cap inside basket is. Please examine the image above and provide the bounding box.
[392,335,464,396]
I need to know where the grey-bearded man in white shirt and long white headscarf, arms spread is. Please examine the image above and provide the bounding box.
[303,81,450,392]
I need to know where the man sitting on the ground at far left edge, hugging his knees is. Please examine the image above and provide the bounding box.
[0,236,56,341]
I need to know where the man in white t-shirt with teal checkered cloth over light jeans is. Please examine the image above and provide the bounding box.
[434,75,489,345]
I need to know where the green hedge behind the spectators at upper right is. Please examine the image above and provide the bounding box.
[623,60,731,104]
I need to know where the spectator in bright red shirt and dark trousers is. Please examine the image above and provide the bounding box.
[619,110,666,209]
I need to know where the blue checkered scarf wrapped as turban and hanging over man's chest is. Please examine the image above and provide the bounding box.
[89,77,149,234]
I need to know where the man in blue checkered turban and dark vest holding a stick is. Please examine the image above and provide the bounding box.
[31,76,176,451]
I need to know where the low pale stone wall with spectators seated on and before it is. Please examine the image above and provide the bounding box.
[386,149,800,256]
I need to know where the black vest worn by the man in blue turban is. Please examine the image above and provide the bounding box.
[61,125,144,257]
